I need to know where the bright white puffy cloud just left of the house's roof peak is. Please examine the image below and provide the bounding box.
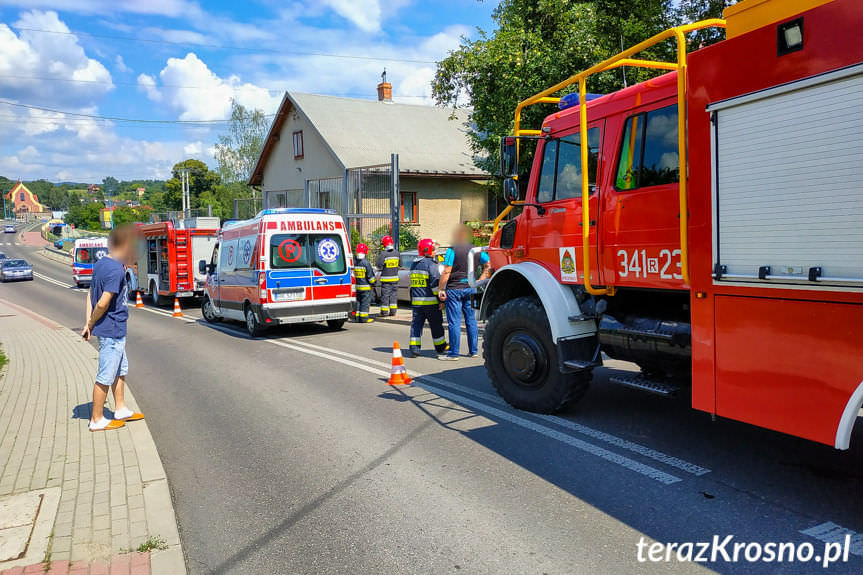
[138,52,281,120]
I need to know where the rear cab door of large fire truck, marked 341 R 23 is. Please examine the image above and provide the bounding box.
[602,105,682,288]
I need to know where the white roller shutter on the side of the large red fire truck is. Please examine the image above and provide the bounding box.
[708,66,863,285]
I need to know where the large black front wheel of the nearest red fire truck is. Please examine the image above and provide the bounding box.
[483,297,591,413]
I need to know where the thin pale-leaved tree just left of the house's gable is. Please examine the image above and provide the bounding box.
[216,99,270,184]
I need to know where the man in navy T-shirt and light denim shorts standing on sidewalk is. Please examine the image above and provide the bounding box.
[81,227,144,431]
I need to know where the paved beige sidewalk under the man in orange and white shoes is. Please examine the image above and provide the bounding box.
[0,299,186,575]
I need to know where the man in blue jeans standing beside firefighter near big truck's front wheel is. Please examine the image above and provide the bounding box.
[440,225,489,361]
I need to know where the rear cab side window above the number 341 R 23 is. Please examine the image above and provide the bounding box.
[615,105,680,190]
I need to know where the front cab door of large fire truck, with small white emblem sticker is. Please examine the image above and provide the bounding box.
[526,121,603,284]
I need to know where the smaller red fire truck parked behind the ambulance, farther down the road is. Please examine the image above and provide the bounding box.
[130,217,219,306]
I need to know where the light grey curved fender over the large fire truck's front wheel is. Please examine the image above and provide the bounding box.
[480,262,596,342]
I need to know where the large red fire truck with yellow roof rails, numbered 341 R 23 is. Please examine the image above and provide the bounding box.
[480,0,863,449]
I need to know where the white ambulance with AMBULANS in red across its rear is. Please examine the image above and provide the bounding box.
[198,208,355,337]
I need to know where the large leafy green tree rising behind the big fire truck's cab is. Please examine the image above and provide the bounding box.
[432,0,674,189]
